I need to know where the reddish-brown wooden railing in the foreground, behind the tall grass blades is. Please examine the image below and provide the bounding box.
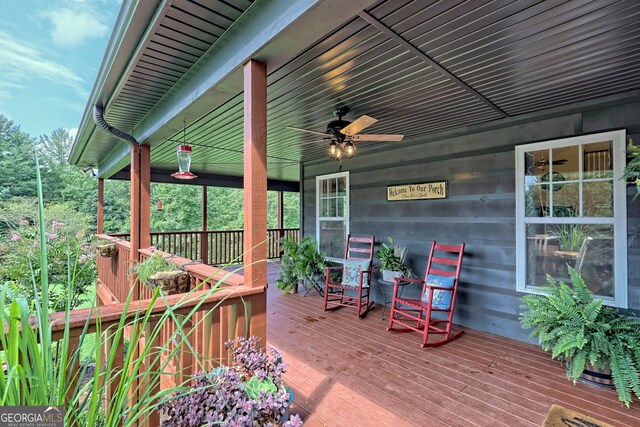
[91,233,266,425]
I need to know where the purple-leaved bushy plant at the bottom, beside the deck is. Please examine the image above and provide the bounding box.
[159,337,303,427]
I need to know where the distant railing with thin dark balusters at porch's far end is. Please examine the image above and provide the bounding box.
[111,228,300,265]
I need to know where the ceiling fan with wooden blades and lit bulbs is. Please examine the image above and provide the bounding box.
[286,106,404,160]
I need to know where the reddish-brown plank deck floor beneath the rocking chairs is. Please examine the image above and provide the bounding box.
[240,267,640,427]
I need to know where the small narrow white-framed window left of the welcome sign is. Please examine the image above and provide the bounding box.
[316,172,349,259]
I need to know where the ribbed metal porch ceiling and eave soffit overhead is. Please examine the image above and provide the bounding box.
[72,0,640,181]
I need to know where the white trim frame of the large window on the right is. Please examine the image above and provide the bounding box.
[515,130,628,308]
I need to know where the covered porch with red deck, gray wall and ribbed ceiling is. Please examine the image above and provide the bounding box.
[66,0,640,426]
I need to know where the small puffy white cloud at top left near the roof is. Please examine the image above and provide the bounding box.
[44,8,109,47]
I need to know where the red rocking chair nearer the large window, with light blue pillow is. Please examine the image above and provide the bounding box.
[387,241,464,347]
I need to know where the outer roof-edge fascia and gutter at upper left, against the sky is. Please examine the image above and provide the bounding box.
[69,0,171,164]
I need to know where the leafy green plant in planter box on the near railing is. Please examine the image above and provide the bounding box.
[131,252,189,295]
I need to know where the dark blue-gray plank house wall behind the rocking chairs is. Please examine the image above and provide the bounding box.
[303,95,640,340]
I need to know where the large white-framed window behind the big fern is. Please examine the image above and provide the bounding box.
[516,131,627,308]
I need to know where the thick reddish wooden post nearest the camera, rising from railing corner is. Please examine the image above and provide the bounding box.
[244,59,267,345]
